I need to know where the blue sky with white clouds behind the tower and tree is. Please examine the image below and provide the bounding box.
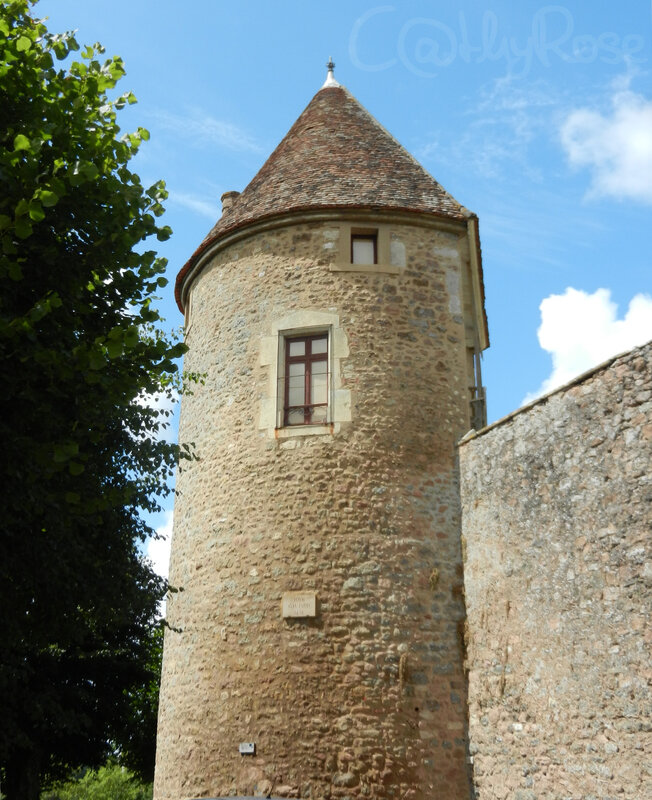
[33,0,652,571]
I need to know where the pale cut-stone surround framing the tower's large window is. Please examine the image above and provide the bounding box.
[258,311,351,439]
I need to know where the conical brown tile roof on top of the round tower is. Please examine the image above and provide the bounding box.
[176,81,469,302]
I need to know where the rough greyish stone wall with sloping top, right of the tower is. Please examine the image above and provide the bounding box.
[460,343,652,800]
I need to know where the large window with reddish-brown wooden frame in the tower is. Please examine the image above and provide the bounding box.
[283,332,329,426]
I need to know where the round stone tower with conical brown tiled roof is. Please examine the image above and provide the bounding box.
[155,69,488,800]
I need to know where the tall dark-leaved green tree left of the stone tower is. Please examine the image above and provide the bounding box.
[0,0,183,800]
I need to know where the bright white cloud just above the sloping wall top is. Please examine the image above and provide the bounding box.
[523,288,652,403]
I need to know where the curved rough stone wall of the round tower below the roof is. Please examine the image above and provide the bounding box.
[155,216,470,800]
